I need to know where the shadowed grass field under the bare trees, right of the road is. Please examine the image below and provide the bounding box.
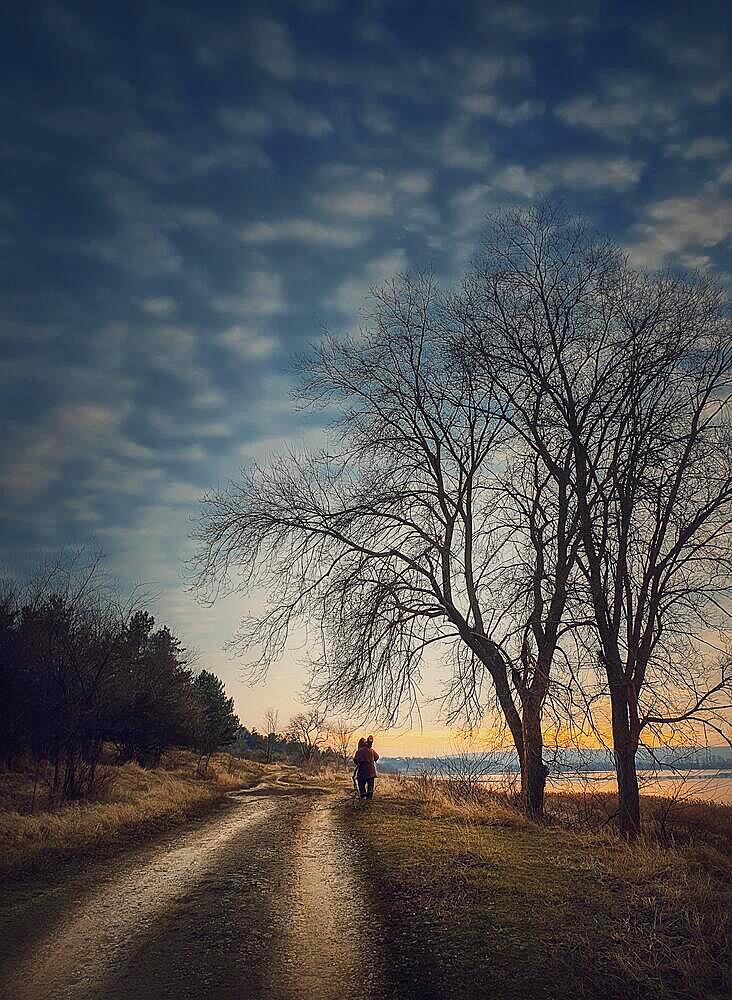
[341,778,732,1000]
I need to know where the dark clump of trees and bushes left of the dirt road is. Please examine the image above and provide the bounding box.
[0,555,239,803]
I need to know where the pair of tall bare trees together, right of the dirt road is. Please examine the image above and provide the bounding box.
[192,205,732,837]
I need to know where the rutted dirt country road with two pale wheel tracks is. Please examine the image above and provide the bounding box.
[0,782,385,1000]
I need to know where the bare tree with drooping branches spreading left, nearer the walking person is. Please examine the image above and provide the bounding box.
[194,275,576,816]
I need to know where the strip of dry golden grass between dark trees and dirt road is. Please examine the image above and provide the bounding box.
[0,750,269,874]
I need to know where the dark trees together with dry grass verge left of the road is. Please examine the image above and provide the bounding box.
[0,551,280,874]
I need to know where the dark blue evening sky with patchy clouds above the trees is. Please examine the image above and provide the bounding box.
[0,0,732,753]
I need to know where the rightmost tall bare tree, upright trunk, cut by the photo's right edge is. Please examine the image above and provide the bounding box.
[458,208,732,836]
